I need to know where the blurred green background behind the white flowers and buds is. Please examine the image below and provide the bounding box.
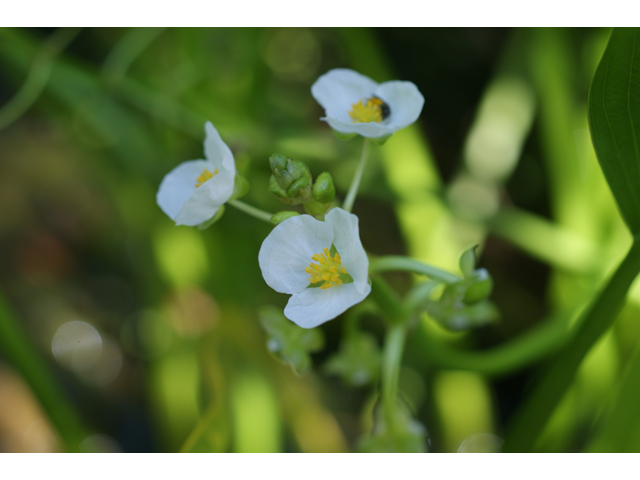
[0,28,640,452]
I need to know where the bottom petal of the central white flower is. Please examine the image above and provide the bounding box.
[284,283,371,328]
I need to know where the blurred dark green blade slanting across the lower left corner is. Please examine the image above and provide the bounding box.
[0,294,88,452]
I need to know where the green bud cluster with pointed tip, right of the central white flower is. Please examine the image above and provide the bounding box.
[426,247,499,330]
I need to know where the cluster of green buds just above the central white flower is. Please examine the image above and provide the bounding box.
[269,153,336,218]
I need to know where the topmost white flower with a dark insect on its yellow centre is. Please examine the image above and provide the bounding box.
[311,68,424,138]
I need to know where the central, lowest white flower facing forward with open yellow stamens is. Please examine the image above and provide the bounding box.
[258,208,371,328]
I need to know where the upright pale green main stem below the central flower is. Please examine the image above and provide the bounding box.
[382,323,406,435]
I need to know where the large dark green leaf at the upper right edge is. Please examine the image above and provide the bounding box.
[589,28,640,235]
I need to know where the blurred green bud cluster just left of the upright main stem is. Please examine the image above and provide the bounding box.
[325,331,381,387]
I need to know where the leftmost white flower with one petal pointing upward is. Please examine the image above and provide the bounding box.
[156,122,236,226]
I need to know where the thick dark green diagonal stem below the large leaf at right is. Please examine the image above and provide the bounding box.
[503,238,640,452]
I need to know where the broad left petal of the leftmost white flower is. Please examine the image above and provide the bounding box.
[156,160,213,220]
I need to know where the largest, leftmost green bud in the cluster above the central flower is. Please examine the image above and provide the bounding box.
[269,153,311,205]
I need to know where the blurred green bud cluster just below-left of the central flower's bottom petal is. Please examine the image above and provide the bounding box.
[259,306,324,374]
